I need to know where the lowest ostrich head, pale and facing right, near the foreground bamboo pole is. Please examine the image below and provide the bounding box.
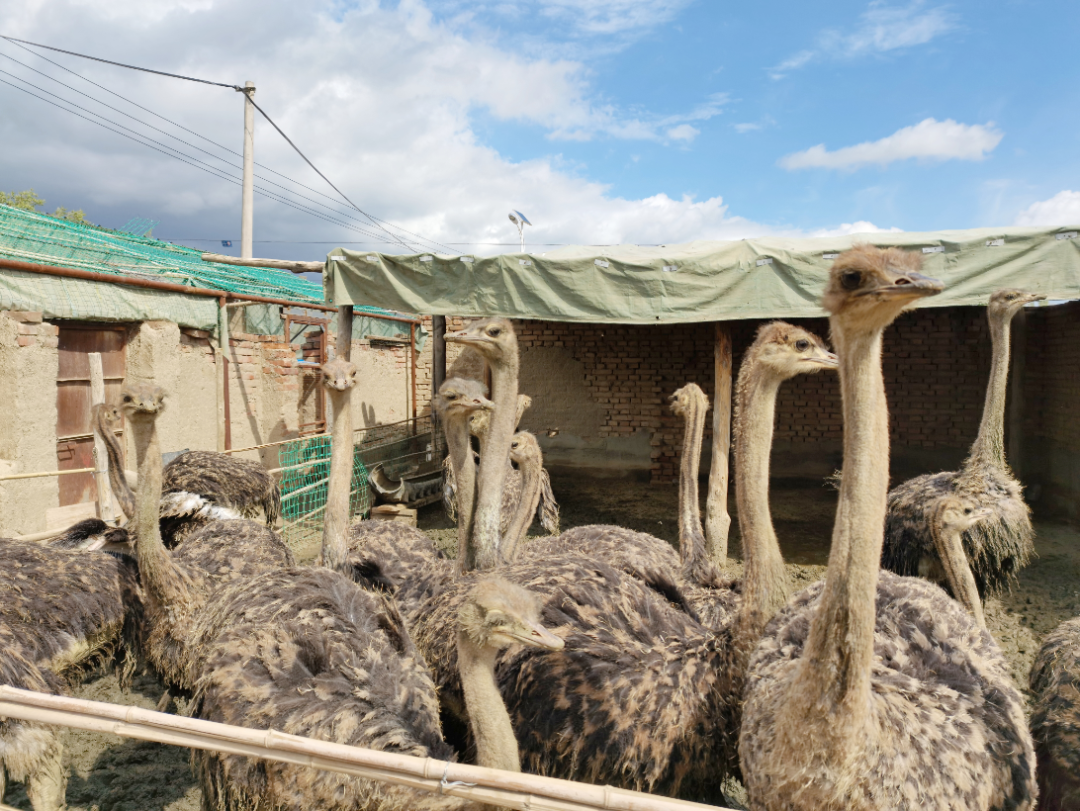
[458,578,563,650]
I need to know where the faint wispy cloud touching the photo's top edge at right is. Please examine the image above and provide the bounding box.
[769,0,957,79]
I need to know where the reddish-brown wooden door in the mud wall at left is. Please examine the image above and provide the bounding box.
[56,323,126,506]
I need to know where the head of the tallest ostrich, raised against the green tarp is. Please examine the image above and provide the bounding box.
[822,245,945,332]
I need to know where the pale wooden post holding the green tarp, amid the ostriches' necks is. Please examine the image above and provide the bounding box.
[705,322,731,566]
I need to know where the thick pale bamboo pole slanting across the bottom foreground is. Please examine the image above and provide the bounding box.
[0,686,730,811]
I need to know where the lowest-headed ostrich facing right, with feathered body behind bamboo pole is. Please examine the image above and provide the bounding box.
[193,568,563,811]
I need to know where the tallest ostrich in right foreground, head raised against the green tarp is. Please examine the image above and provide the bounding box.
[739,246,1036,811]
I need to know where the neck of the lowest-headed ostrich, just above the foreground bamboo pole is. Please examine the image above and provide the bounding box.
[458,632,522,772]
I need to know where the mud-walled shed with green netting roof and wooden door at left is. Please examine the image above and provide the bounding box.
[0,205,430,537]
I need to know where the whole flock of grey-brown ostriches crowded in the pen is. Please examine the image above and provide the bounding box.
[0,246,1080,811]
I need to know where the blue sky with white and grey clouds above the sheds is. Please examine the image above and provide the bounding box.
[0,0,1080,256]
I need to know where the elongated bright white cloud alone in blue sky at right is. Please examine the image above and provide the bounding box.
[779,119,1004,170]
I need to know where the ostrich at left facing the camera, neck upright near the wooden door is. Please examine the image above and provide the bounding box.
[121,382,294,690]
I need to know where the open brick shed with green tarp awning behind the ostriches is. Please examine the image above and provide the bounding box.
[324,228,1080,515]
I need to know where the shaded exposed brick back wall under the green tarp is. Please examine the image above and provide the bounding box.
[509,308,990,482]
